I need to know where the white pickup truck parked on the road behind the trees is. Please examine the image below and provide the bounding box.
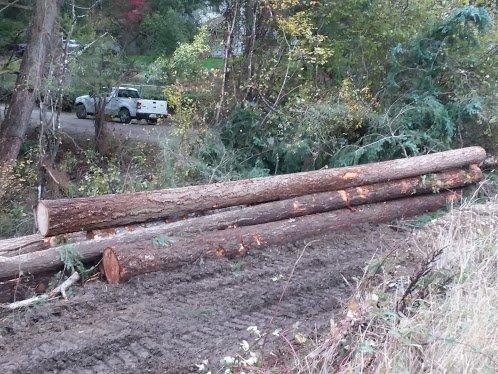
[74,87,168,123]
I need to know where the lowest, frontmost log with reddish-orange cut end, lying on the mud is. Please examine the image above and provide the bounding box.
[103,192,458,283]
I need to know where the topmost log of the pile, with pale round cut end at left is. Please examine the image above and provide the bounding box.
[37,147,486,236]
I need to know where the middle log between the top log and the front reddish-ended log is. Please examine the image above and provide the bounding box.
[0,166,482,280]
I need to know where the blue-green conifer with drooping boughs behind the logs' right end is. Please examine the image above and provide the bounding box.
[336,6,491,164]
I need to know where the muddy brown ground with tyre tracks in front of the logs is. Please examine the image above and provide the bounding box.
[0,226,409,373]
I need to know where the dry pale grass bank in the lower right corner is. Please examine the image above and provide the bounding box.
[294,198,498,373]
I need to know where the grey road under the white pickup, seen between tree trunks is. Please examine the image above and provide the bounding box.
[0,105,169,145]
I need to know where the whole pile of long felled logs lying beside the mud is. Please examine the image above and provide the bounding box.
[0,147,486,283]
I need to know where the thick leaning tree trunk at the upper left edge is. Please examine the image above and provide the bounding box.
[0,0,59,165]
